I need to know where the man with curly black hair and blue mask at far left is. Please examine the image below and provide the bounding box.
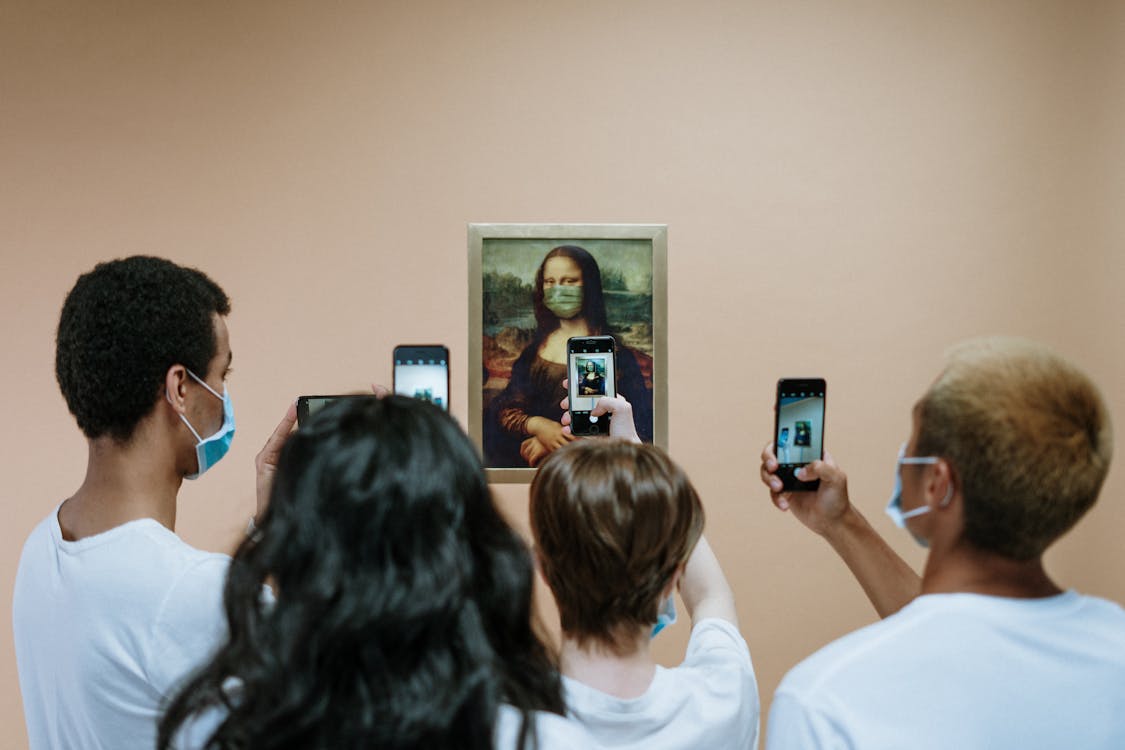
[12,256,291,750]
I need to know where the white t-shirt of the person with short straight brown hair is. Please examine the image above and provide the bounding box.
[563,618,759,750]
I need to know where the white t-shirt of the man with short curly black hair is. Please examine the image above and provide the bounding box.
[12,510,231,750]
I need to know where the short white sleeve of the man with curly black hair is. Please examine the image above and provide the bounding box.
[145,554,231,696]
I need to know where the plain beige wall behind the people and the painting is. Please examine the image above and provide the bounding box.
[0,0,1125,747]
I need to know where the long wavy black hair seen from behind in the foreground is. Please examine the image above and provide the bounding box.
[158,396,565,750]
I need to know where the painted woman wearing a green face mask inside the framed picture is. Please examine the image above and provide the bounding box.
[485,245,653,467]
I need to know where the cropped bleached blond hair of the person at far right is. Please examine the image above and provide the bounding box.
[916,338,1113,560]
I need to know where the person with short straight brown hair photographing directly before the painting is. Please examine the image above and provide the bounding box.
[531,397,758,750]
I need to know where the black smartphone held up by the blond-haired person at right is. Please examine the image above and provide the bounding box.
[774,378,827,491]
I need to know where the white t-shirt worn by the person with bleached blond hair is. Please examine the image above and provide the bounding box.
[766,591,1125,750]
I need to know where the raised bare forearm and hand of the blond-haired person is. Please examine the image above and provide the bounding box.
[762,443,921,617]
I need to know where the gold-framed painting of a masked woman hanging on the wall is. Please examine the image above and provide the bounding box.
[469,224,668,482]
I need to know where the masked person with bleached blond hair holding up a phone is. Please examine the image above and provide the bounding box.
[762,338,1125,750]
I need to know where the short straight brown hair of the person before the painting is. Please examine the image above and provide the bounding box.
[531,439,703,648]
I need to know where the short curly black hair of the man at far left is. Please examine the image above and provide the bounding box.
[55,255,231,442]
